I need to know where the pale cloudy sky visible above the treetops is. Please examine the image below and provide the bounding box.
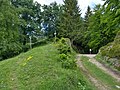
[34,0,104,17]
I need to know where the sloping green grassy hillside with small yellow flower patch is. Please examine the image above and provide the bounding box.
[0,44,93,90]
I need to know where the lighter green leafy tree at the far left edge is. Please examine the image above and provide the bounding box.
[0,0,22,59]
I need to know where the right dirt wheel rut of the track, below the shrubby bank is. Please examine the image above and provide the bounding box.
[84,54,120,82]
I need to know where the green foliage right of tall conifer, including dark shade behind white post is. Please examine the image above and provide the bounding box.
[75,0,120,53]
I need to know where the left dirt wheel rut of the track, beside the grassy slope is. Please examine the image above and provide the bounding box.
[77,55,110,90]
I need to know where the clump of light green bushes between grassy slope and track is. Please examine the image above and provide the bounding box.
[57,38,76,69]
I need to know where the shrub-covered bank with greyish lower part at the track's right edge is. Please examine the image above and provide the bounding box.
[98,31,120,70]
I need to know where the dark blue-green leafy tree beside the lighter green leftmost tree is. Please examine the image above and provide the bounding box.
[11,0,42,45]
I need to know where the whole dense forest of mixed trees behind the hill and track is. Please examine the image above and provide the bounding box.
[0,0,120,60]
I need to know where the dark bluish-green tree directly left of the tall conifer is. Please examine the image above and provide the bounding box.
[42,2,61,38]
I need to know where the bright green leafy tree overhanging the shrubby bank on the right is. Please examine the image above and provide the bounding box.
[87,0,120,53]
